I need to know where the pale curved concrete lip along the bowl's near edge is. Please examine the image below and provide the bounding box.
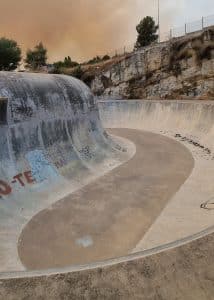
[0,226,214,280]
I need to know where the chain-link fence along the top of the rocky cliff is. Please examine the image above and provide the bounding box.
[96,15,214,57]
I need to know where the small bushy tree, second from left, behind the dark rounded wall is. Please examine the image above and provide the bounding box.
[25,42,47,70]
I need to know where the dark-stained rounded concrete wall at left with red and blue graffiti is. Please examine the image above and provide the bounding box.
[0,72,127,272]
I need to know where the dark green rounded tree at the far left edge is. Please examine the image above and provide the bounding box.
[0,37,21,71]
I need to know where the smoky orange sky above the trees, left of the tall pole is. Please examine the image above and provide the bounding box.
[0,0,177,62]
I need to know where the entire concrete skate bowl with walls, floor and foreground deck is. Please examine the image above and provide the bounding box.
[0,73,214,300]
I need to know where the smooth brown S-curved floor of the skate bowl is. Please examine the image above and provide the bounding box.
[18,129,194,270]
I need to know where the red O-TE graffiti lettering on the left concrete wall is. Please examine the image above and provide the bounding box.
[0,171,35,197]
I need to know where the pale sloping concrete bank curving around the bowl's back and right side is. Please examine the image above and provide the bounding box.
[99,100,214,253]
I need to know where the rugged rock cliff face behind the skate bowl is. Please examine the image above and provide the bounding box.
[91,27,214,100]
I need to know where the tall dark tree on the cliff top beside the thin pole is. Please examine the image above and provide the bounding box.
[135,16,158,49]
